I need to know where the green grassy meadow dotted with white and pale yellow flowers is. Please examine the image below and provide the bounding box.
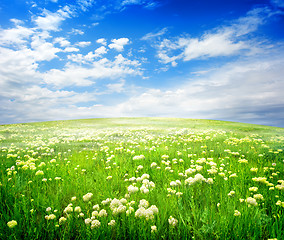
[0,118,284,240]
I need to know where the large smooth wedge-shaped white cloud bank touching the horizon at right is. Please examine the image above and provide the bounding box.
[112,51,284,126]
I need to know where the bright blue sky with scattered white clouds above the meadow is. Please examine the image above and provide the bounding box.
[0,0,284,127]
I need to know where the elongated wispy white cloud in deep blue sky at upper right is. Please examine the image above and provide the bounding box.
[156,8,273,66]
